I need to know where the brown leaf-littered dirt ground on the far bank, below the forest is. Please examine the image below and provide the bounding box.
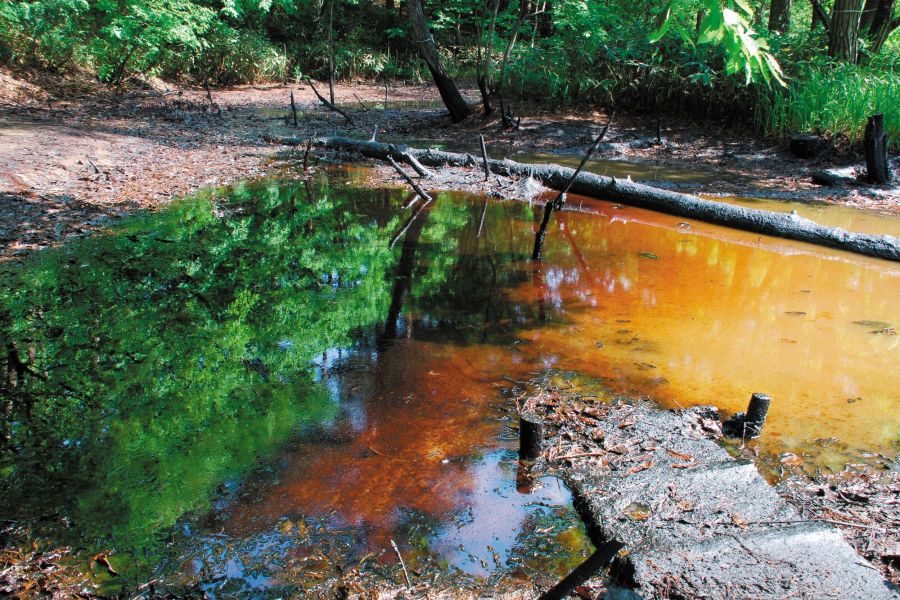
[0,71,900,260]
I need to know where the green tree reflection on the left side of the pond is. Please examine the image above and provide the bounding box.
[0,182,396,572]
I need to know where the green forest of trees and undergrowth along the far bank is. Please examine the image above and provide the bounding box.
[0,0,900,149]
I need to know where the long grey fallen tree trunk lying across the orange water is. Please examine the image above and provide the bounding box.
[272,136,900,262]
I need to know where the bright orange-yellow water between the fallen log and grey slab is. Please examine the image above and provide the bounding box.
[517,200,900,464]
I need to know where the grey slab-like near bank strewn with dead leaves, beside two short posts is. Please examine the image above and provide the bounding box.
[520,380,898,598]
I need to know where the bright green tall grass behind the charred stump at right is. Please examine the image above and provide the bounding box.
[755,62,900,150]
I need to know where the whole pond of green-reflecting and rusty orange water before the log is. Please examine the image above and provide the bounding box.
[0,170,900,596]
